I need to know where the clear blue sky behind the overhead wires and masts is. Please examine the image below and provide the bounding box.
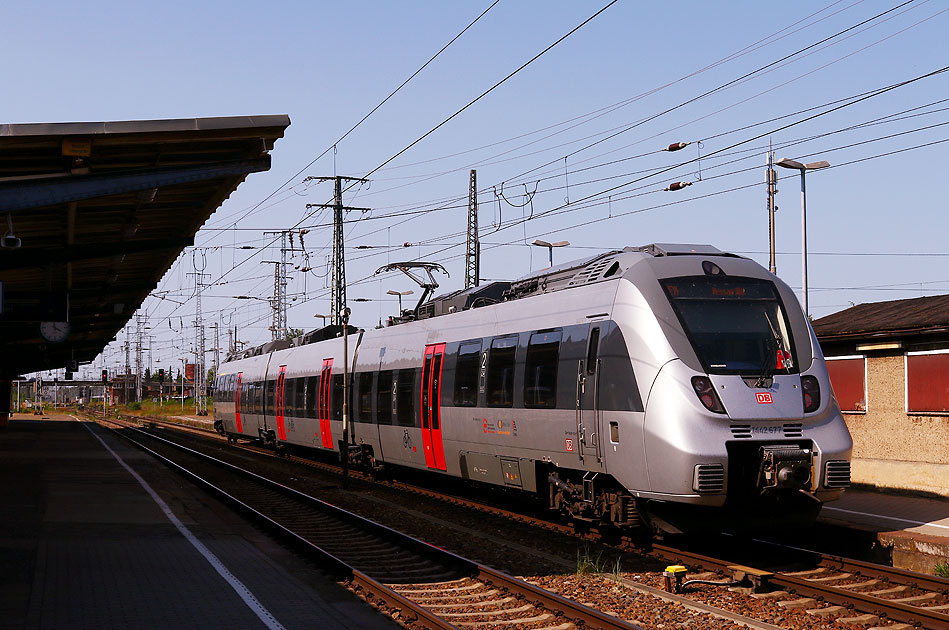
[0,0,949,376]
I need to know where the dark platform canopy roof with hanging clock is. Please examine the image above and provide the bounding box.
[0,115,290,379]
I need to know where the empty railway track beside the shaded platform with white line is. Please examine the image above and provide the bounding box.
[96,421,638,630]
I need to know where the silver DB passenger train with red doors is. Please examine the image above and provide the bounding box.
[214,244,852,532]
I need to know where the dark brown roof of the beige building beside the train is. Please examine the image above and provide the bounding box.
[812,295,949,341]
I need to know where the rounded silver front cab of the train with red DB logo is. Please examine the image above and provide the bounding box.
[614,256,852,531]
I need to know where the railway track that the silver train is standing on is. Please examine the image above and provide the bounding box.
[105,423,949,630]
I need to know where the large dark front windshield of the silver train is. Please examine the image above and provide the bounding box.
[662,275,798,376]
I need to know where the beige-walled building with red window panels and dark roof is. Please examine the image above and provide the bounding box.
[813,295,949,496]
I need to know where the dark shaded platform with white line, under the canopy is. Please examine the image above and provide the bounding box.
[0,414,399,630]
